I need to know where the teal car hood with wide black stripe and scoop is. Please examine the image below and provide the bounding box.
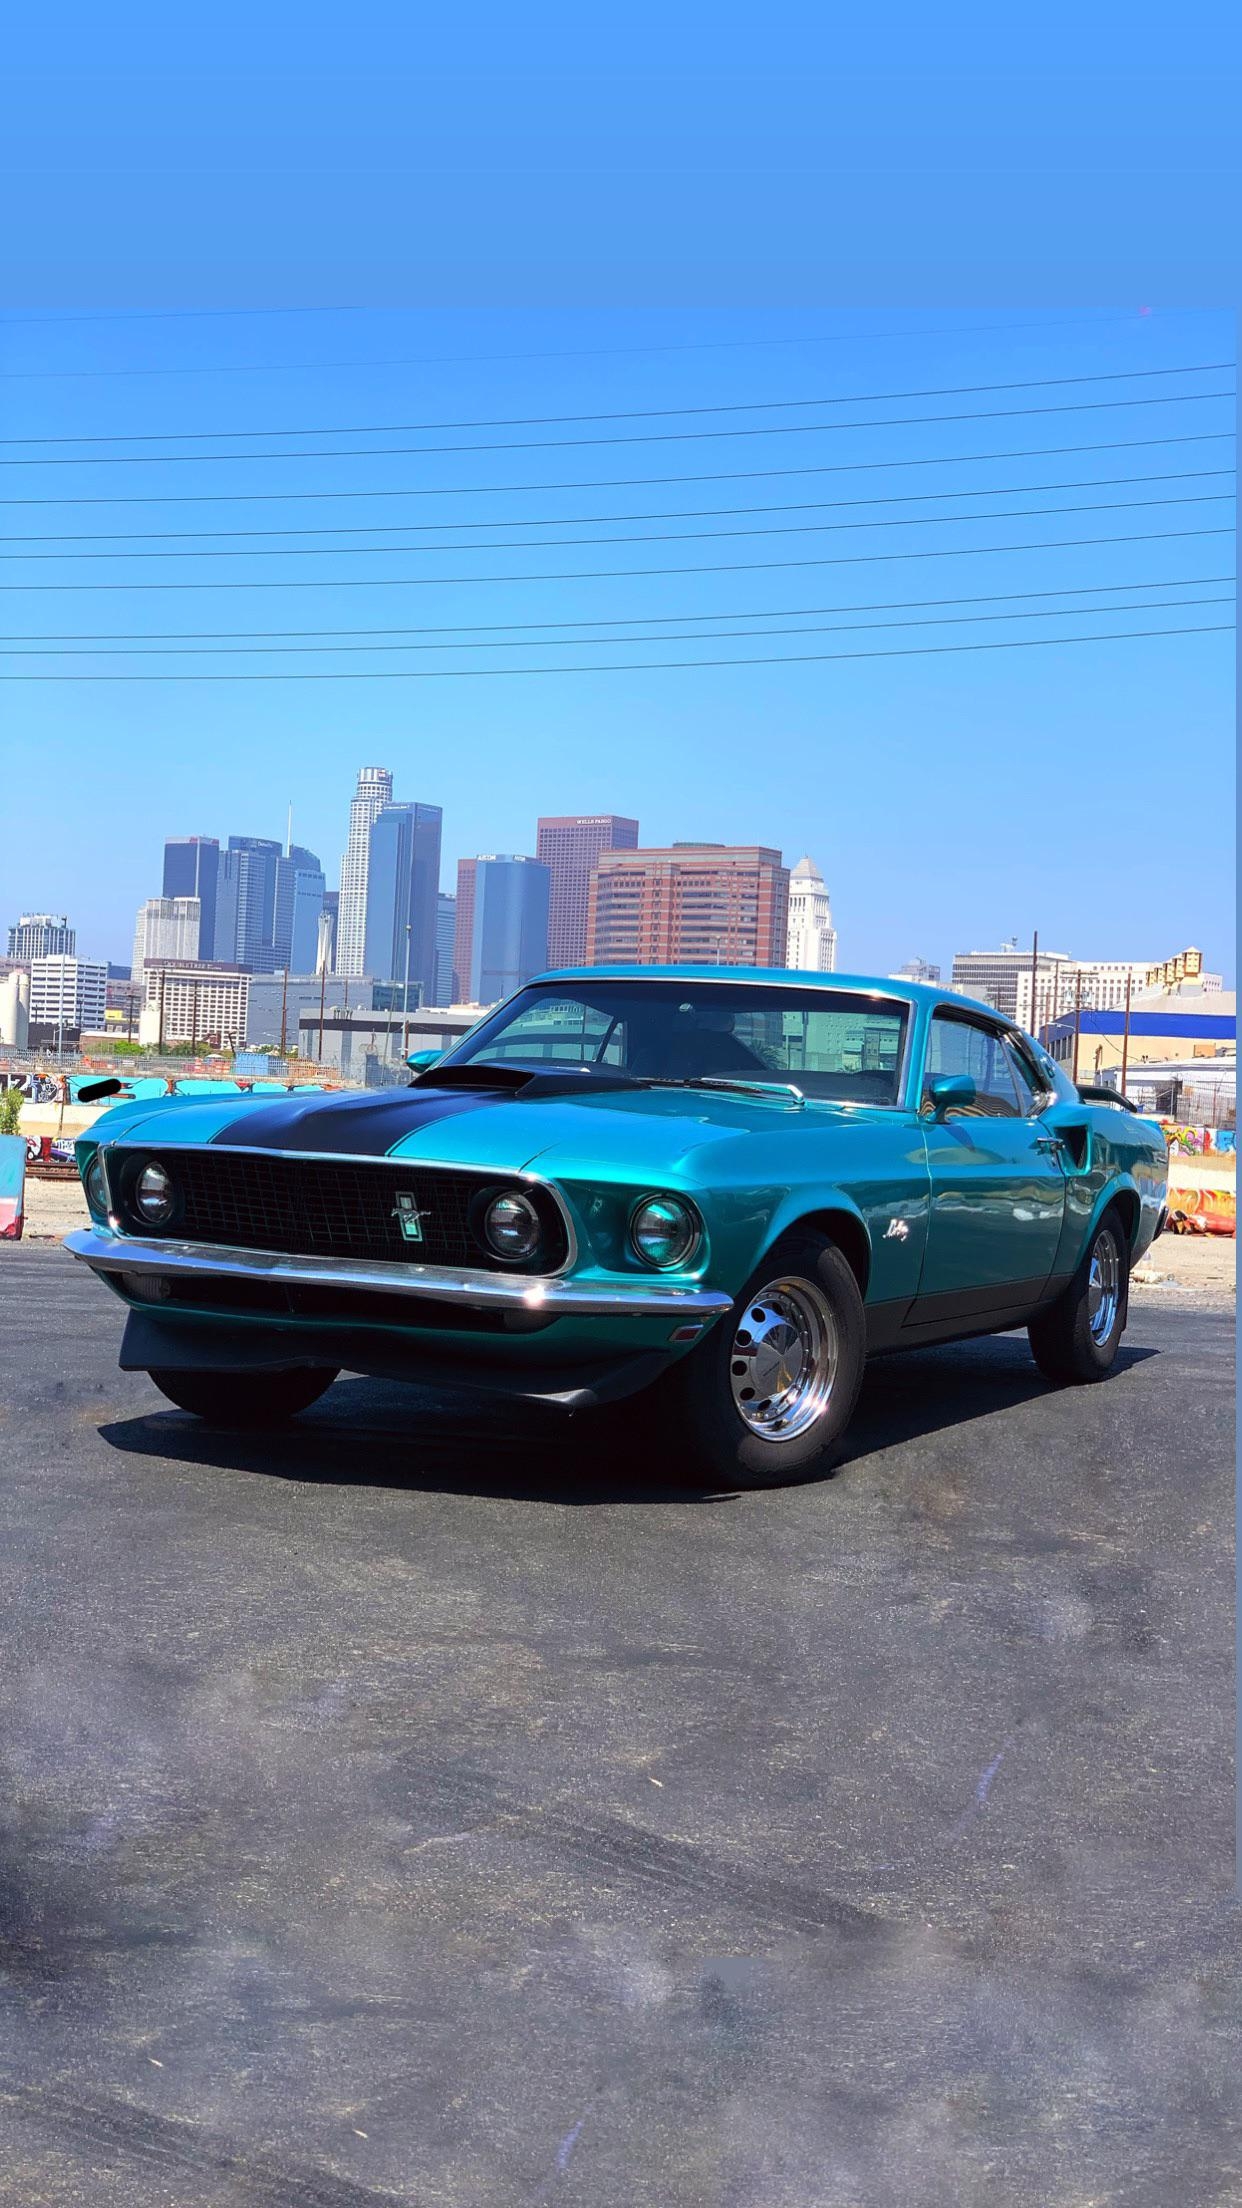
[91,1082,880,1177]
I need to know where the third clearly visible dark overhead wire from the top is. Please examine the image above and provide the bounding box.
[0,415,1233,506]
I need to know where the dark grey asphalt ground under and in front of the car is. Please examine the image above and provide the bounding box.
[0,1248,1242,2208]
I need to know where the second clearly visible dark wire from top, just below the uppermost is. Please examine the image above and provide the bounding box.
[0,391,1238,468]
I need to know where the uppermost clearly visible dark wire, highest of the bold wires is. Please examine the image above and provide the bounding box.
[0,360,1235,446]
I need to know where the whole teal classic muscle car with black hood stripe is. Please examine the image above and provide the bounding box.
[69,967,1167,1484]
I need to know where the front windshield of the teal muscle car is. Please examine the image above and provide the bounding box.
[446,976,908,1104]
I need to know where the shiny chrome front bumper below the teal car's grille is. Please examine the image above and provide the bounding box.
[64,1228,731,1320]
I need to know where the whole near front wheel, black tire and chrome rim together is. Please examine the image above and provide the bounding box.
[656,1228,866,1488]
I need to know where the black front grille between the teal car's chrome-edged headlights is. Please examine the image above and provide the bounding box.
[111,1148,566,1272]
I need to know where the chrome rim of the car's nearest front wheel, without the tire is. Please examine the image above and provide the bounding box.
[729,1281,838,1442]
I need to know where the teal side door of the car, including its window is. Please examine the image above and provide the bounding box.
[908,1007,1065,1325]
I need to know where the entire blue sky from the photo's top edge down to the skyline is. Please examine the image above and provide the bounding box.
[0,0,1240,972]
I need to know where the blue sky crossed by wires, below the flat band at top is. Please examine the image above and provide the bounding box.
[0,307,1233,967]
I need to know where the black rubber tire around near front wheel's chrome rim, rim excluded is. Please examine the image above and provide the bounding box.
[672,1228,866,1486]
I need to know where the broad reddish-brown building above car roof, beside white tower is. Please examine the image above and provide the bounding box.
[586,843,789,967]
